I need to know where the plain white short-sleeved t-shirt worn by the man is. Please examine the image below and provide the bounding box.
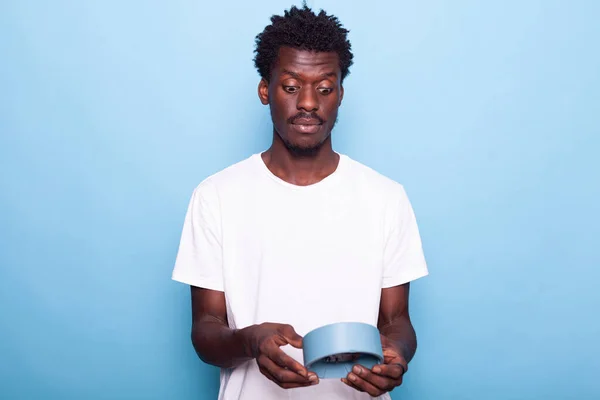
[173,154,428,400]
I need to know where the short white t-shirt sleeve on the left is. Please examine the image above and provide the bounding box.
[172,181,224,291]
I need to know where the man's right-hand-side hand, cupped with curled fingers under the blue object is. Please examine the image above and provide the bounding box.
[342,336,408,397]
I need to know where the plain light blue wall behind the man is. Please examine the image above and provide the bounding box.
[0,0,600,400]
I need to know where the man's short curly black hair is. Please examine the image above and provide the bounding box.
[254,3,354,82]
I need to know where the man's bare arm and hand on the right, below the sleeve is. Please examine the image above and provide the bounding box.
[342,283,417,397]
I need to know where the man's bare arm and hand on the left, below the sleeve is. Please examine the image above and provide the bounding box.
[191,286,318,389]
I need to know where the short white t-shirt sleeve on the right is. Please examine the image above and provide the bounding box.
[382,186,428,288]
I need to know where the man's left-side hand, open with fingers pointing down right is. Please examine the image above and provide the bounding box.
[244,323,319,389]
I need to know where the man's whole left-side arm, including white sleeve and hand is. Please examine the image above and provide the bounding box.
[178,185,318,388]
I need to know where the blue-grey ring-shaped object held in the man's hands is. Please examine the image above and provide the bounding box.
[302,322,383,379]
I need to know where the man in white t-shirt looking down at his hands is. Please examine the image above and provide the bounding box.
[173,5,427,400]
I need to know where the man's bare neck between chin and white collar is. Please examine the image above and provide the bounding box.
[262,133,340,186]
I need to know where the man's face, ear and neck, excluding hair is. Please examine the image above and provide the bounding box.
[258,47,344,186]
